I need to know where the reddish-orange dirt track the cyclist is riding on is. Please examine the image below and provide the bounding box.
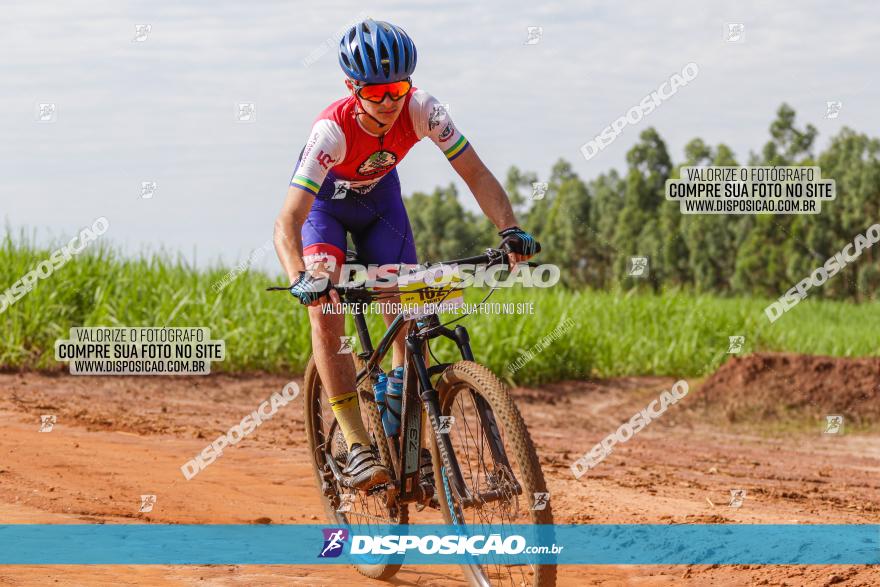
[0,356,880,586]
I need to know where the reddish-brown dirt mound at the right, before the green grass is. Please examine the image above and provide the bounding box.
[697,353,880,426]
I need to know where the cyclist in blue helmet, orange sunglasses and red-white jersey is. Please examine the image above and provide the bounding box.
[275,19,538,489]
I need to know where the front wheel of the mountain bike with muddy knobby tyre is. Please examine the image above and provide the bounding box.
[430,361,556,587]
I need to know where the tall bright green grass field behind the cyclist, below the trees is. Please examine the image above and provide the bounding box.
[0,234,880,384]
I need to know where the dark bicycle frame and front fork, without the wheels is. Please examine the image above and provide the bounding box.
[344,302,522,507]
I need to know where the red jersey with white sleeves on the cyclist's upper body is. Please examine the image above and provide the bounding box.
[290,88,468,194]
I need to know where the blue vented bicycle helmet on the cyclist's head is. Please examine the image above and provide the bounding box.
[339,18,416,84]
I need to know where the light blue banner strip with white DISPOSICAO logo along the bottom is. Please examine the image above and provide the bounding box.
[0,524,880,565]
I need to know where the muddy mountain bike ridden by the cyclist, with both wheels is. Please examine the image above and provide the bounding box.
[271,249,556,587]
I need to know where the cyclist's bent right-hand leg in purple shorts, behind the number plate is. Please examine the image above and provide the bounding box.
[352,169,418,367]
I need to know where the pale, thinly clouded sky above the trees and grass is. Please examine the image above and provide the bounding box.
[0,0,880,269]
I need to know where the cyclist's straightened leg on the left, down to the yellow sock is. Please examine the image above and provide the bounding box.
[302,200,370,448]
